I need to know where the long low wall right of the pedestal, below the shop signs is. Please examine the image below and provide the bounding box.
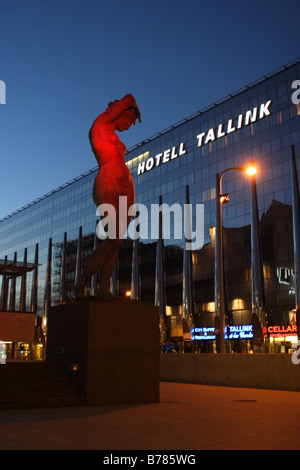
[160,354,300,391]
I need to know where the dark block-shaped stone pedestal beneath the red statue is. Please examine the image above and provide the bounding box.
[46,297,159,405]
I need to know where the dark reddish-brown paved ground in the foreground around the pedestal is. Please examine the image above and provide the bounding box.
[0,383,300,451]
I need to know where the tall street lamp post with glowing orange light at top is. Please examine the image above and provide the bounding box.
[215,165,256,353]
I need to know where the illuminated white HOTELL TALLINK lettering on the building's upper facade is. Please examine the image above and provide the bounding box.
[137,100,272,175]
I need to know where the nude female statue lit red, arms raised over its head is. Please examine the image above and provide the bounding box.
[75,94,141,297]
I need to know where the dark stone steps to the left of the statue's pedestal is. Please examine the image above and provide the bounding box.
[0,361,85,410]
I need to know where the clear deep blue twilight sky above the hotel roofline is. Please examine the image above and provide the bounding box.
[0,0,300,218]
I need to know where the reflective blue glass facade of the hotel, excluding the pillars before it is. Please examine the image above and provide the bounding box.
[0,58,300,351]
